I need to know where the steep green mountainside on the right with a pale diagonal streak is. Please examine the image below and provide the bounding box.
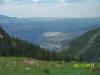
[57,28,100,61]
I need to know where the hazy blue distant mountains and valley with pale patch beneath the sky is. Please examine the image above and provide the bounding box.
[0,15,100,50]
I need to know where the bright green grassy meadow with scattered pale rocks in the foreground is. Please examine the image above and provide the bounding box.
[0,57,100,75]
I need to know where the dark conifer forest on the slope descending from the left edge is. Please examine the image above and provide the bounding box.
[0,27,55,60]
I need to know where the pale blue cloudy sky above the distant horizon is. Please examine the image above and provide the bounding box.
[0,0,100,18]
